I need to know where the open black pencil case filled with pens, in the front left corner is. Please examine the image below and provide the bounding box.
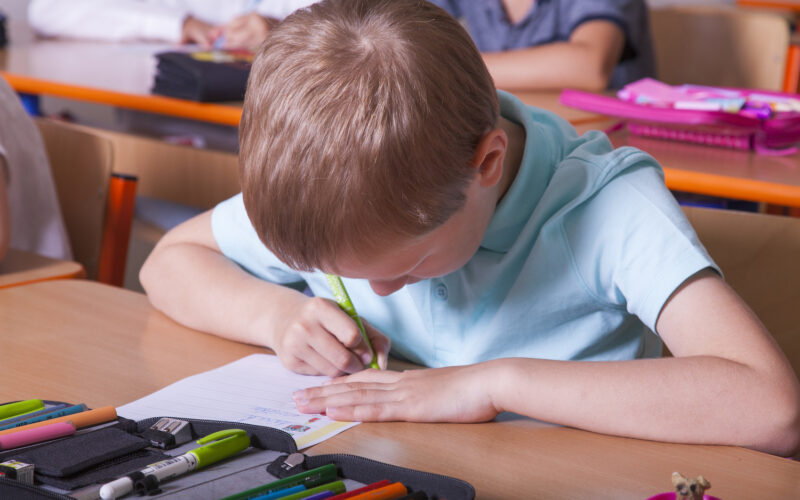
[0,404,475,500]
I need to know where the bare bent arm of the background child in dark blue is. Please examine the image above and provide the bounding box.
[483,20,625,91]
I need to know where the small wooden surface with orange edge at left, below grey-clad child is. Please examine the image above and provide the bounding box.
[0,248,86,288]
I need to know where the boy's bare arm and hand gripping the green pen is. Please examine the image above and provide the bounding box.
[140,211,389,376]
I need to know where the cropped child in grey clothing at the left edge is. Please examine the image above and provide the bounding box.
[0,78,72,259]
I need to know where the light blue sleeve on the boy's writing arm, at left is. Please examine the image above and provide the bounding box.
[211,193,304,285]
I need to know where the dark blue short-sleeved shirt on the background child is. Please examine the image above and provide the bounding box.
[431,0,655,88]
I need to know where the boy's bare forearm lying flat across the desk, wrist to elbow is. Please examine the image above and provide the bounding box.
[487,356,800,455]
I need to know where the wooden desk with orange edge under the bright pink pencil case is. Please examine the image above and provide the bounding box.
[576,120,800,207]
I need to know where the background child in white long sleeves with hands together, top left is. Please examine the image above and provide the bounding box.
[28,0,313,48]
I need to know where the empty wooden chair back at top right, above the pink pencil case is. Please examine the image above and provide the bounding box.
[650,5,790,91]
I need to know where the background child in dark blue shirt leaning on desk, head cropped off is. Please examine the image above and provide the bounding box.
[431,0,655,91]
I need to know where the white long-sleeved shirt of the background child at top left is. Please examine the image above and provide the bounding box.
[28,0,315,43]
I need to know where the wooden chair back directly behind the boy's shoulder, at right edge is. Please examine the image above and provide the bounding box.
[684,207,800,374]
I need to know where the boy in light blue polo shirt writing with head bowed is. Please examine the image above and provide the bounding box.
[141,0,800,454]
